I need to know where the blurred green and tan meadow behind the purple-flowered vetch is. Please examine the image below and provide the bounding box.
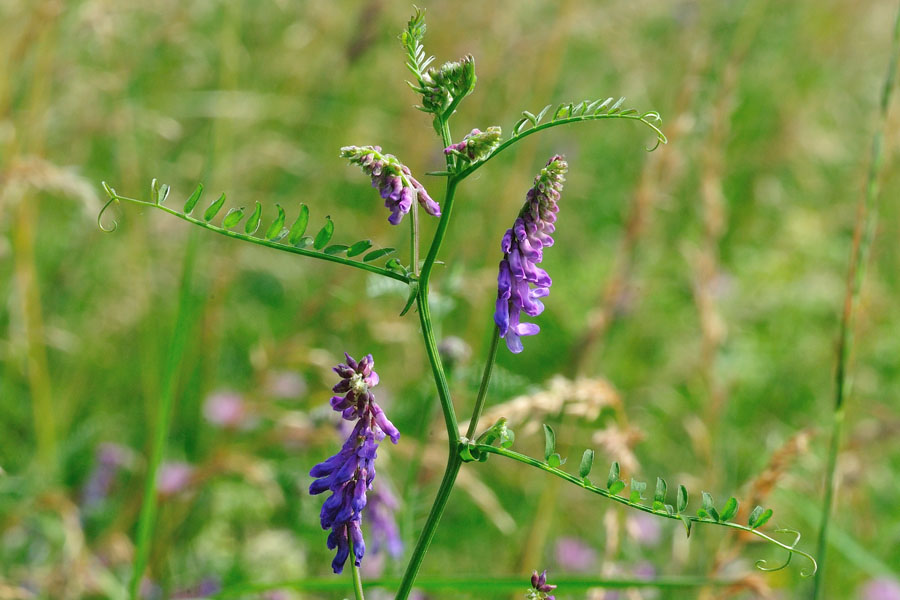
[0,0,900,599]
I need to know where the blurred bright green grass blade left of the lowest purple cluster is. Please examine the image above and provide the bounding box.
[129,235,197,600]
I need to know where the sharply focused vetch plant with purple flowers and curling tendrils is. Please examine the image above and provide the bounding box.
[98,10,816,600]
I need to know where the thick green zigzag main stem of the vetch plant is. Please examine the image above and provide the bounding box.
[396,120,462,600]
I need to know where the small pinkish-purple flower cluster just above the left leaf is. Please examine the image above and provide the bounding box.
[341,146,441,225]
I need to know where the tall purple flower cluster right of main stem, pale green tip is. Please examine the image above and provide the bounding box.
[494,156,569,353]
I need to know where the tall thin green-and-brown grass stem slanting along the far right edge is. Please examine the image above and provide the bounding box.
[812,3,900,600]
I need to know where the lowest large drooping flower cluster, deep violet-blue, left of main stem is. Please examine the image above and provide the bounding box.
[309,354,400,573]
